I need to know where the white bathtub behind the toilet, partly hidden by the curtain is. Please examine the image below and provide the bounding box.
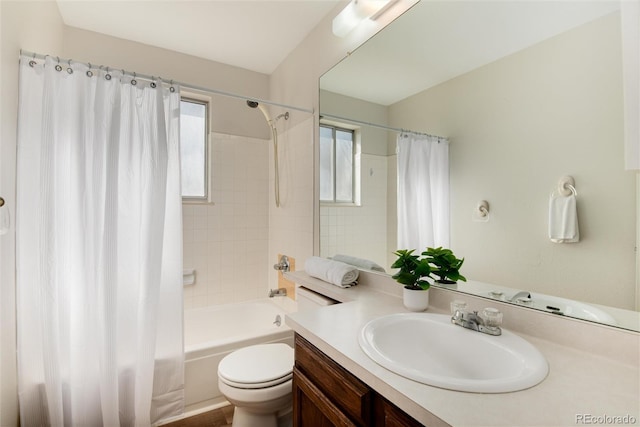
[184,297,295,414]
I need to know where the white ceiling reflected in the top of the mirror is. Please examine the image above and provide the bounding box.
[320,0,619,105]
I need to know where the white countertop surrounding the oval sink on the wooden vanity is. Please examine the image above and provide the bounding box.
[286,273,640,427]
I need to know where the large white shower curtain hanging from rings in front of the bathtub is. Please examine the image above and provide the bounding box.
[16,57,184,426]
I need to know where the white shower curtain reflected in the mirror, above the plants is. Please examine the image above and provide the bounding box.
[397,132,449,253]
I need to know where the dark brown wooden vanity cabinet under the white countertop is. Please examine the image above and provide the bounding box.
[293,334,422,427]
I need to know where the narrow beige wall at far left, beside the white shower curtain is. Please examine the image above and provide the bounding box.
[0,1,63,426]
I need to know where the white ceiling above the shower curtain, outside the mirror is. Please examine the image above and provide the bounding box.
[57,0,340,74]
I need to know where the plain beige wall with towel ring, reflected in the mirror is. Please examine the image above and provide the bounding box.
[390,11,636,309]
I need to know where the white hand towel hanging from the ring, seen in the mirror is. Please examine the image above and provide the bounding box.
[549,193,580,243]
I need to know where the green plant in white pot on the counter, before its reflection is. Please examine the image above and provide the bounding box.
[391,249,431,311]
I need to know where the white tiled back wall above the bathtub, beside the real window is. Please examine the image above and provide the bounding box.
[183,134,271,308]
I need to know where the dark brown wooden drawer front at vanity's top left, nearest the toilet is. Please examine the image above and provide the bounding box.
[295,335,373,425]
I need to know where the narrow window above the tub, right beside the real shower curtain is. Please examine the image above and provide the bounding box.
[180,98,209,202]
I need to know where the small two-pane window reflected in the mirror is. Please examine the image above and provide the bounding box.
[320,125,355,203]
